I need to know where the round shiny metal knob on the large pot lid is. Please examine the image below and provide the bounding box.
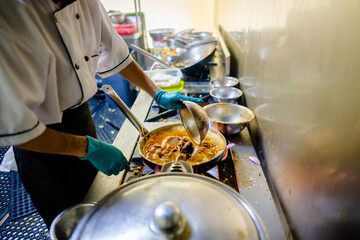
[150,201,187,238]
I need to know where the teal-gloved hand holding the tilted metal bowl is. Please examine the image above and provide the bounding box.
[154,90,204,109]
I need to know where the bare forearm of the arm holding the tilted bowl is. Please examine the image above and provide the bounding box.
[119,60,160,97]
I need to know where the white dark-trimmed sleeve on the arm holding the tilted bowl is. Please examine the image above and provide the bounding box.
[97,2,133,78]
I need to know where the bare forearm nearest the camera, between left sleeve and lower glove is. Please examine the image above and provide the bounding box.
[16,128,88,157]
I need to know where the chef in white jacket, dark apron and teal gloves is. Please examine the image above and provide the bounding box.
[0,0,201,227]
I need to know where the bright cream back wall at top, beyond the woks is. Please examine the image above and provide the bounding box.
[100,0,215,31]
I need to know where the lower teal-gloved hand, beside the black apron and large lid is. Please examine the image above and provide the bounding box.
[80,136,130,176]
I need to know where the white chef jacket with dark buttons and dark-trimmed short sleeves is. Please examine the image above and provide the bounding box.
[0,0,132,146]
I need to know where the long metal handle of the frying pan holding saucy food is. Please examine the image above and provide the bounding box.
[103,85,149,136]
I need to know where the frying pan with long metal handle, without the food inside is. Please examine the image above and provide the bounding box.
[103,85,226,173]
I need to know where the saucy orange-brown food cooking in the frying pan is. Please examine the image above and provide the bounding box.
[144,128,224,165]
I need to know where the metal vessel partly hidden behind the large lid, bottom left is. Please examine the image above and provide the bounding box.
[50,203,95,240]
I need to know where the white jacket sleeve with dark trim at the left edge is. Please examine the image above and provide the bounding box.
[0,32,47,146]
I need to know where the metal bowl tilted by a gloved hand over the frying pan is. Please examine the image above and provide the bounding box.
[179,101,209,145]
